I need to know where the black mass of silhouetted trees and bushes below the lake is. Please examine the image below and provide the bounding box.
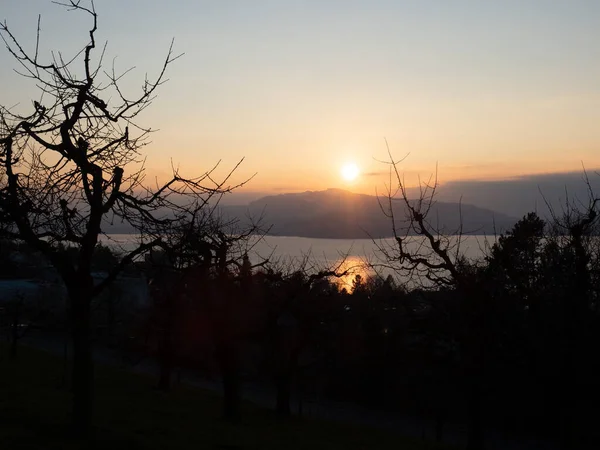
[3,202,600,449]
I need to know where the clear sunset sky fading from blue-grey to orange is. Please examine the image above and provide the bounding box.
[0,0,600,197]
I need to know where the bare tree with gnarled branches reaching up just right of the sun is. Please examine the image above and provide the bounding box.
[374,147,487,450]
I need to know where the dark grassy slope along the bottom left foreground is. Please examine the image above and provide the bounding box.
[0,346,446,450]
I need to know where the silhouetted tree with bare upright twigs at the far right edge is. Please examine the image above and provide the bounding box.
[548,181,600,449]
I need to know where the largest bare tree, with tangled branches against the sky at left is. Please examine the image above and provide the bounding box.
[0,0,248,435]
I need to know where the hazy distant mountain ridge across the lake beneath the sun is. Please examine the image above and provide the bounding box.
[221,189,517,239]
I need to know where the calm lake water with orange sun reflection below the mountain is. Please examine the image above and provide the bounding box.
[101,234,495,287]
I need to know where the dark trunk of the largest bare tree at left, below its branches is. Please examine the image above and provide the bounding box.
[71,289,94,438]
